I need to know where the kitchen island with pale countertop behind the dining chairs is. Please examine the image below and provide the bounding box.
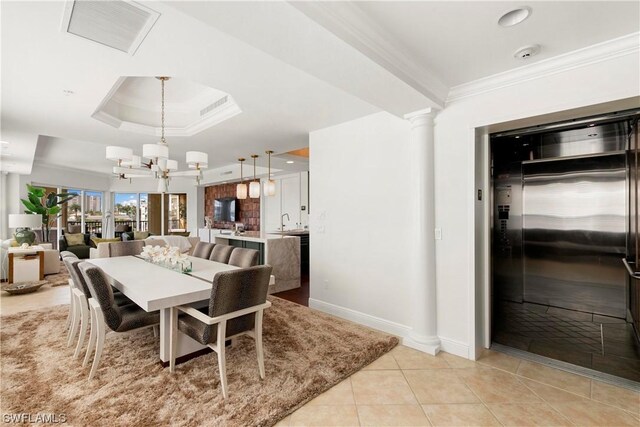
[198,228,300,293]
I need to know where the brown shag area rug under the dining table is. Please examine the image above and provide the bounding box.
[0,297,398,426]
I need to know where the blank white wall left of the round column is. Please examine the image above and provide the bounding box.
[309,113,415,333]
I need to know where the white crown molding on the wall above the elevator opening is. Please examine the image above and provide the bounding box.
[446,33,640,104]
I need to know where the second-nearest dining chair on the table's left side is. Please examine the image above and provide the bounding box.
[62,257,133,365]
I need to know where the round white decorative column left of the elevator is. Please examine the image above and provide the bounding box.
[403,108,440,355]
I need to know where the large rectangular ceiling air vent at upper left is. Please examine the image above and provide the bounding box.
[62,0,160,55]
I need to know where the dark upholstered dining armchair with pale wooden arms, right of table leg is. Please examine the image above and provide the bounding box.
[169,265,271,399]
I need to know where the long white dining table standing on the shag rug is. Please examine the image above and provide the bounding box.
[89,256,238,362]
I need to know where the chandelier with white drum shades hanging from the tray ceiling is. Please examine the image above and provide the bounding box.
[106,77,209,193]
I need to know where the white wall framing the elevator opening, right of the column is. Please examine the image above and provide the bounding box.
[435,50,640,357]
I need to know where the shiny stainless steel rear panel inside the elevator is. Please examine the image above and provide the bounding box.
[522,153,627,318]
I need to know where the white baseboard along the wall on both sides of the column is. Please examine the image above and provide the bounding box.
[309,298,469,359]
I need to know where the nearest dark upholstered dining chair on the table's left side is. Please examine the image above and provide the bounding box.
[78,262,160,379]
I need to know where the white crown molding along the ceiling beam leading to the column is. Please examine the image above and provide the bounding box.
[289,1,449,107]
